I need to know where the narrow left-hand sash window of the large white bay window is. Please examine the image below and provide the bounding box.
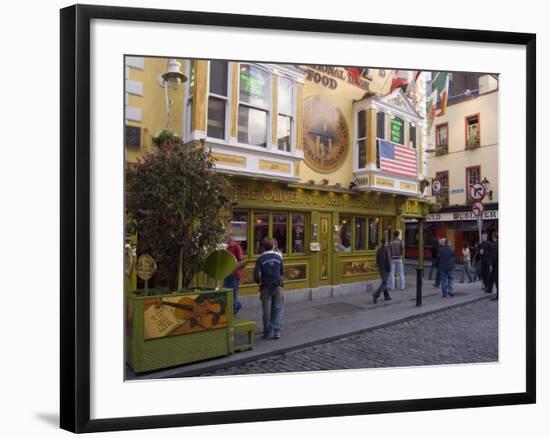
[206,61,228,139]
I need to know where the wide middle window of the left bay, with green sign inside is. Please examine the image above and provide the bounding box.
[238,64,271,147]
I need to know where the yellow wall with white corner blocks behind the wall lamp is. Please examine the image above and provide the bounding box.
[127,57,186,162]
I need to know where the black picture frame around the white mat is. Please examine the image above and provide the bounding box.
[60,5,536,433]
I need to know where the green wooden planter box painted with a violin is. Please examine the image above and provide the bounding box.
[126,289,233,373]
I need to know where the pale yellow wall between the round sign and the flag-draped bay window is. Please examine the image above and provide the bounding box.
[300,66,391,188]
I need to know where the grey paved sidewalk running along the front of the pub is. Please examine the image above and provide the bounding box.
[126,275,488,380]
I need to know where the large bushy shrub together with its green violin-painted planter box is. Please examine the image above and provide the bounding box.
[126,131,238,372]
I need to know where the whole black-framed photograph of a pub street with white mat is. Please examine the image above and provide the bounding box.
[60,5,536,433]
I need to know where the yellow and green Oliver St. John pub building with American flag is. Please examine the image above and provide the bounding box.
[126,58,427,305]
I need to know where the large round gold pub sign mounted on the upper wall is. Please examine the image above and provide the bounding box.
[303,96,349,173]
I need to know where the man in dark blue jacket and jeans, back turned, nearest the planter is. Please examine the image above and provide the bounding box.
[254,237,284,339]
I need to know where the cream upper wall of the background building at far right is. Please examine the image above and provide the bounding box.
[428,91,499,205]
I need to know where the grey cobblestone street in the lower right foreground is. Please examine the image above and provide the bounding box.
[202,300,498,376]
